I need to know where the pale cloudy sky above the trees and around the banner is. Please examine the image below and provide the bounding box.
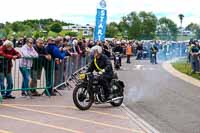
[0,0,200,26]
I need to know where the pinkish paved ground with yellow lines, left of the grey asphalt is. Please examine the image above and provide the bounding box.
[0,90,146,133]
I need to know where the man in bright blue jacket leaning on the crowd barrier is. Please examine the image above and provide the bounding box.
[45,37,66,96]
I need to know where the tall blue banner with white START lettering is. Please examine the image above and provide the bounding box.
[94,0,107,41]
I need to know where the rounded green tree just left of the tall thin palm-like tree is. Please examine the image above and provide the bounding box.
[159,17,178,40]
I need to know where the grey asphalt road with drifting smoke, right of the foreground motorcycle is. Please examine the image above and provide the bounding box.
[118,59,200,133]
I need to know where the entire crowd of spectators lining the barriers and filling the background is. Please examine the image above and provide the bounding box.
[0,36,195,99]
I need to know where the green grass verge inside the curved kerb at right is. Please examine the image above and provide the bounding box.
[172,60,200,80]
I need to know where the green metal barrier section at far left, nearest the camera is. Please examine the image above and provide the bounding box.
[0,57,54,101]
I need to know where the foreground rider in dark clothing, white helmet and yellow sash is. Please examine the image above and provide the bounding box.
[87,46,114,99]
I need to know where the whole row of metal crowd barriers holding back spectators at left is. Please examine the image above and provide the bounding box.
[0,55,90,101]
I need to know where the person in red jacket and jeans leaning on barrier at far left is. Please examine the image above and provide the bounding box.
[0,40,21,99]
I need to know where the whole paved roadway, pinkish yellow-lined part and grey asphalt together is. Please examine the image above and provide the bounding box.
[0,56,200,133]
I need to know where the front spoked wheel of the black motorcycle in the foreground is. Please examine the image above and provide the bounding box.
[73,85,94,110]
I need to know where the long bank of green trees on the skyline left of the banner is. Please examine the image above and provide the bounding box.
[0,19,74,37]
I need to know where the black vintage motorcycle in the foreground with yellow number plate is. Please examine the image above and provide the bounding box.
[73,72,125,110]
